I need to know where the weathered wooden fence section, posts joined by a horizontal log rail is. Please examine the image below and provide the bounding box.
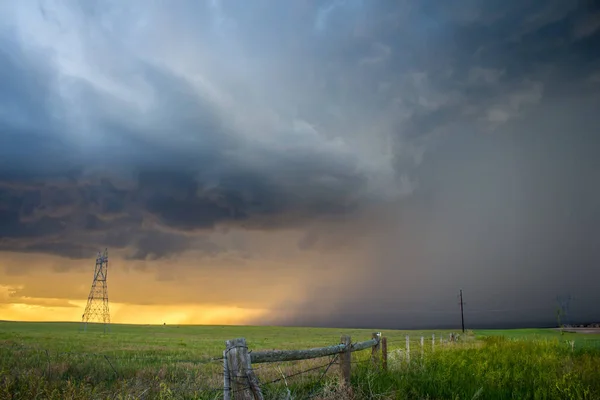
[223,332,387,400]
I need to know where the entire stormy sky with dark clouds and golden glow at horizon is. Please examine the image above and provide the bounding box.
[0,0,600,328]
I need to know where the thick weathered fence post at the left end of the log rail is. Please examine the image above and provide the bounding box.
[225,338,263,400]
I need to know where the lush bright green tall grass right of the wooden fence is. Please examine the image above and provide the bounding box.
[353,337,600,400]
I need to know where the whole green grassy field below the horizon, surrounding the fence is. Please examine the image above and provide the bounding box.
[0,322,600,400]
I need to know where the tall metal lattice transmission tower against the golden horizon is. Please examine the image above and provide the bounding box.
[81,249,110,332]
